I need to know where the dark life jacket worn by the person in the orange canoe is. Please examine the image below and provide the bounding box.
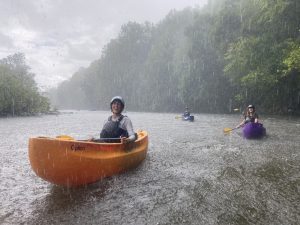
[100,115,128,138]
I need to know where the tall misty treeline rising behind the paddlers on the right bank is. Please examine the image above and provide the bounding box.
[52,0,300,113]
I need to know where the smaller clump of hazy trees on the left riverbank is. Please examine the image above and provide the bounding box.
[0,53,50,116]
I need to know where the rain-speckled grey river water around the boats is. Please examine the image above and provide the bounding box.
[0,111,300,225]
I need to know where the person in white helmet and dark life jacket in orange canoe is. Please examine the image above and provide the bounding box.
[100,96,137,143]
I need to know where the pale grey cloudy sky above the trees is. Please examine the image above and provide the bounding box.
[0,0,207,89]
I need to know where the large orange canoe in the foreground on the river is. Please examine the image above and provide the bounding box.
[29,131,148,187]
